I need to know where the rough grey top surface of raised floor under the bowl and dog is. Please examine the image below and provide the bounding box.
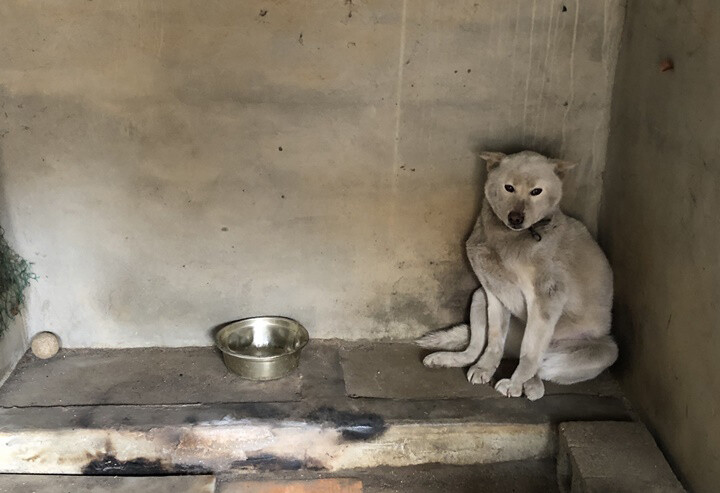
[0,341,623,412]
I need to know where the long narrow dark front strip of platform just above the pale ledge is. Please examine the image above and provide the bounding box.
[0,395,630,432]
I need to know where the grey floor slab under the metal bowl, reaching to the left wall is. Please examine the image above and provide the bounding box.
[0,347,301,407]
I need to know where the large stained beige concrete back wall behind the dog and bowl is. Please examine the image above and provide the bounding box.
[0,0,624,346]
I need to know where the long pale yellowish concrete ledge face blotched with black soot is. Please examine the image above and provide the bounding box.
[0,419,556,475]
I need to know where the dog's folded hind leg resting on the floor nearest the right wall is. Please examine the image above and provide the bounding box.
[538,336,618,385]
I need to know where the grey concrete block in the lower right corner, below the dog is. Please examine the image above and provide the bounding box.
[557,421,685,493]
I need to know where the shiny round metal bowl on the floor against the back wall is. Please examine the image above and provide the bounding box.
[215,317,309,380]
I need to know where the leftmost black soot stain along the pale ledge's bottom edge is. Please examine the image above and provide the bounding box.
[82,454,213,476]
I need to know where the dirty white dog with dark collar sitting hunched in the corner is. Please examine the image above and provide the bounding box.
[417,151,618,400]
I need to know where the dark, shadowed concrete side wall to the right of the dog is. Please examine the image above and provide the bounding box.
[600,0,720,492]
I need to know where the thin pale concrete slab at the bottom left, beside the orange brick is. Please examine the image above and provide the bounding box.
[0,474,215,493]
